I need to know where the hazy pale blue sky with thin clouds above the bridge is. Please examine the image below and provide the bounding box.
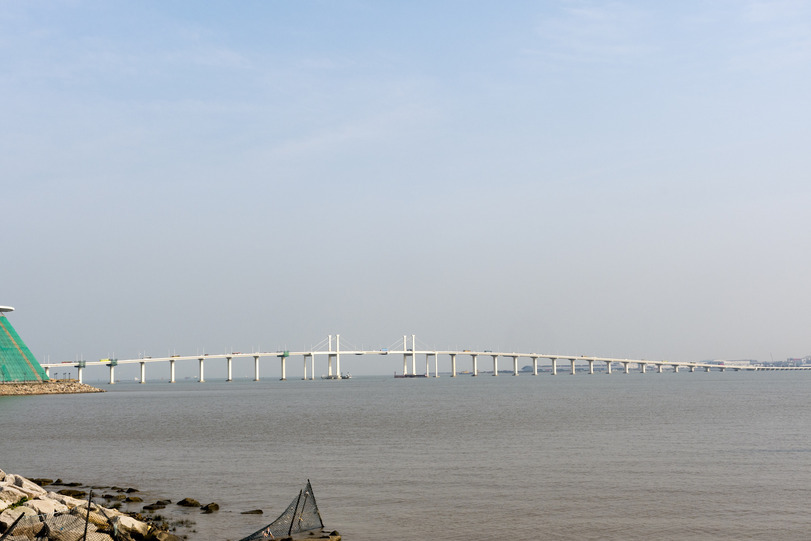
[0,0,811,375]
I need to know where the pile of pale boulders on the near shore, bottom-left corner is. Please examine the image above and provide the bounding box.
[0,470,180,541]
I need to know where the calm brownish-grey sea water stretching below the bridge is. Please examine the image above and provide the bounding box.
[0,372,811,541]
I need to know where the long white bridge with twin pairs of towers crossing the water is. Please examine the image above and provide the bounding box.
[36,334,811,384]
